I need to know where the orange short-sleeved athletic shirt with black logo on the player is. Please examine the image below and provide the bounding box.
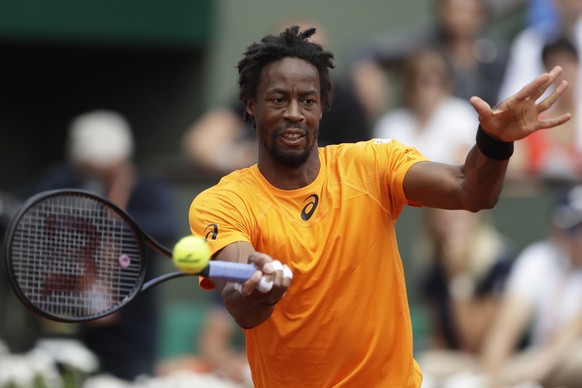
[189,140,426,388]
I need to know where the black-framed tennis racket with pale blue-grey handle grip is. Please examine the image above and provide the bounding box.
[4,189,264,323]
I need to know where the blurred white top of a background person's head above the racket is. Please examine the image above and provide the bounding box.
[68,110,133,168]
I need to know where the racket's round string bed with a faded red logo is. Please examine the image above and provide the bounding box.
[11,196,143,319]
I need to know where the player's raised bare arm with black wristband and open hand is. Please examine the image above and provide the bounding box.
[404,67,571,212]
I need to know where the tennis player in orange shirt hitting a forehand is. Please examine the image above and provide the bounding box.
[189,26,570,388]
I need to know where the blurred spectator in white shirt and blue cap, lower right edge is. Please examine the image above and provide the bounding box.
[483,185,582,388]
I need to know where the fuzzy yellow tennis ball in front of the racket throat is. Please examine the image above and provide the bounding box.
[172,236,210,274]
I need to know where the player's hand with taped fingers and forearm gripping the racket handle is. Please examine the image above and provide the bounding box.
[213,242,291,329]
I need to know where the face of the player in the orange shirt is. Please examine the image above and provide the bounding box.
[246,57,322,168]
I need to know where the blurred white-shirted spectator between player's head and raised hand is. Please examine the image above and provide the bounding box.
[373,48,479,164]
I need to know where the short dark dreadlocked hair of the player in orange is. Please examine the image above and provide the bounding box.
[237,26,335,120]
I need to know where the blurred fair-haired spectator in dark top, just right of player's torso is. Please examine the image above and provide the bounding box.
[418,209,513,383]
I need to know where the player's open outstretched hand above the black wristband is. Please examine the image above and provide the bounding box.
[470,66,572,142]
